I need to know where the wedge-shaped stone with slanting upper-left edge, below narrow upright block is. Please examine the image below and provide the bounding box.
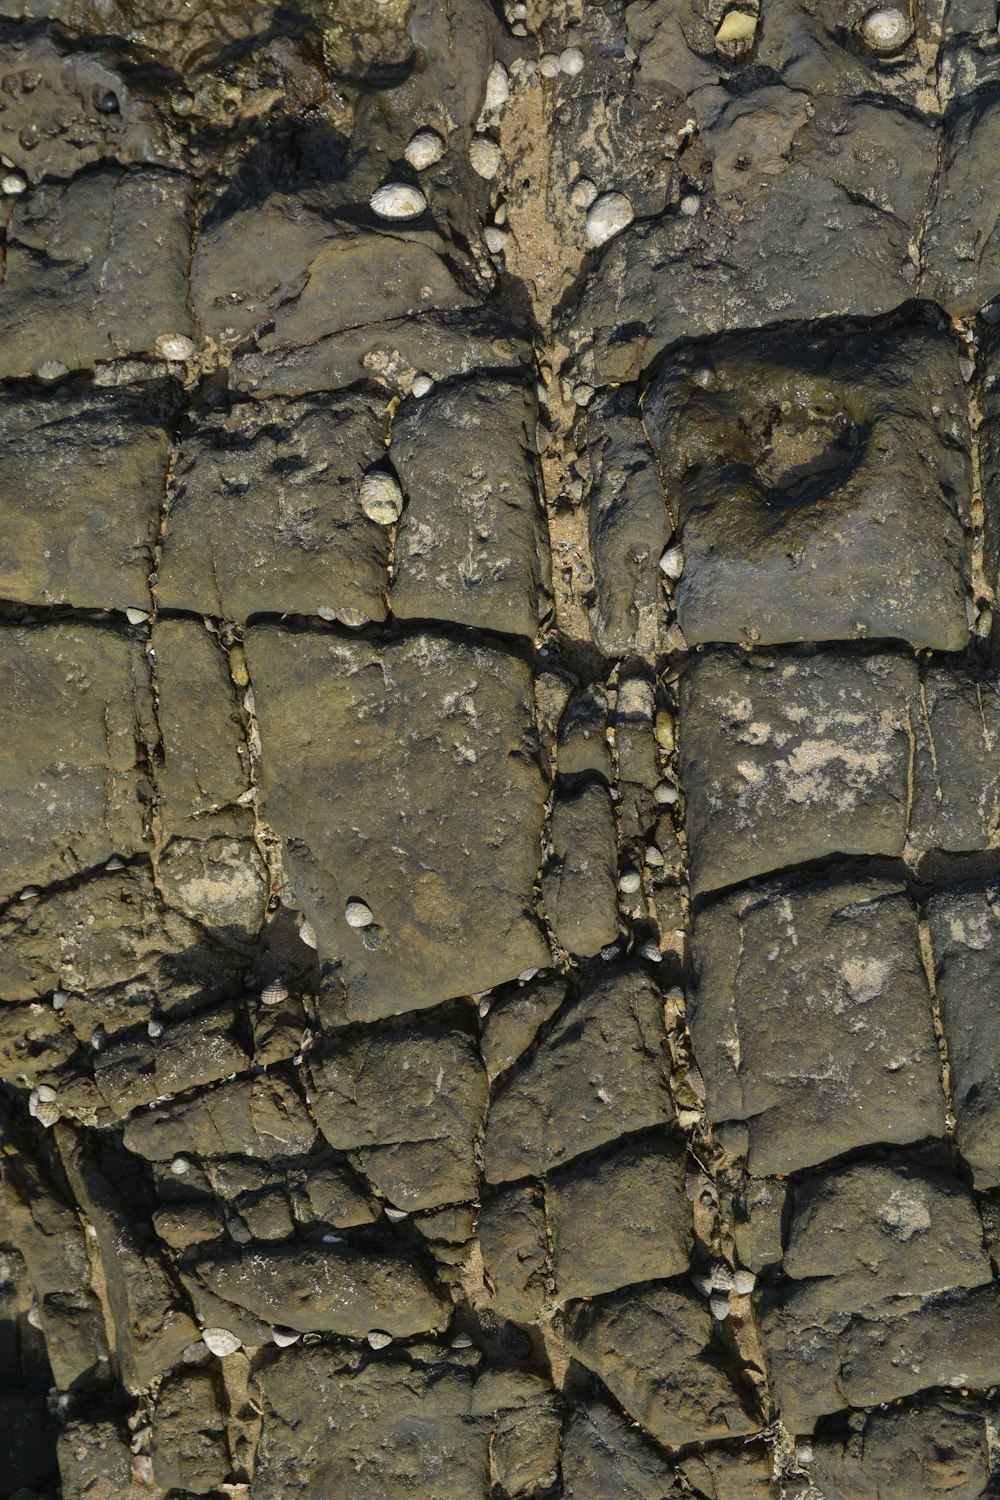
[483,972,673,1182]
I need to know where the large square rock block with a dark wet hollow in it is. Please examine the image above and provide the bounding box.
[643,330,970,651]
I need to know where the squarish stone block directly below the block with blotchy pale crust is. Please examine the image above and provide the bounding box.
[690,879,945,1175]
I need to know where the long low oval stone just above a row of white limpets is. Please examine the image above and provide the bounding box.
[196,1244,450,1338]
